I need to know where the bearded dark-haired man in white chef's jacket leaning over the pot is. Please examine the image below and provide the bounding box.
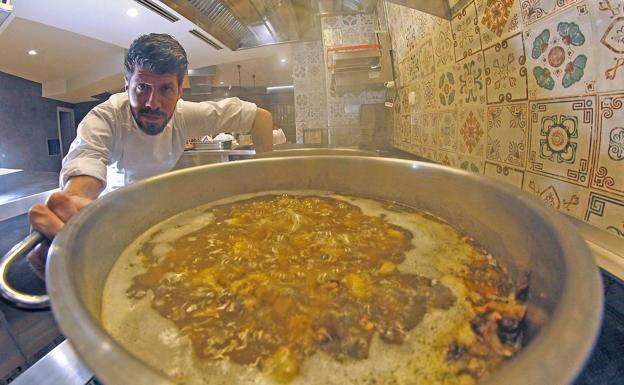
[28,34,273,276]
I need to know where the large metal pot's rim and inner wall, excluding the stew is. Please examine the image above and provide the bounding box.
[47,156,602,385]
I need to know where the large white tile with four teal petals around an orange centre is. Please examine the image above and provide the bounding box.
[524,4,597,99]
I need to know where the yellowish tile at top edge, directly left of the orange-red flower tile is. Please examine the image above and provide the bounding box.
[451,1,481,61]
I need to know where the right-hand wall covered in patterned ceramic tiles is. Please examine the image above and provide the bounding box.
[385,0,624,238]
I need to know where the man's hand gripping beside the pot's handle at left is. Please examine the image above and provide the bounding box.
[27,176,103,279]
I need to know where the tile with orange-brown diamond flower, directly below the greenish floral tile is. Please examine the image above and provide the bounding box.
[457,107,487,157]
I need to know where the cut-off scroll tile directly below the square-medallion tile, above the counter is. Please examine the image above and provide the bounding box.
[522,172,589,219]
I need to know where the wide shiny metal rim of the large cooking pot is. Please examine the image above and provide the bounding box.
[46,155,603,385]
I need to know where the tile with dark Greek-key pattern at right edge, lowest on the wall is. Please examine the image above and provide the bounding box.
[585,192,624,238]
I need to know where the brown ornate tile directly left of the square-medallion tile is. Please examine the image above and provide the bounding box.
[485,103,528,168]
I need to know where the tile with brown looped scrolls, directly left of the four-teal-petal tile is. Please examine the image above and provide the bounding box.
[483,33,528,104]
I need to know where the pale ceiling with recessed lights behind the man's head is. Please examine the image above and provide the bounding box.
[0,0,292,103]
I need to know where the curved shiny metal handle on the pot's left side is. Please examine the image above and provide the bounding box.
[0,231,50,309]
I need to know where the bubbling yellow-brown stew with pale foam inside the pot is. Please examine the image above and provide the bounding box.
[102,192,525,384]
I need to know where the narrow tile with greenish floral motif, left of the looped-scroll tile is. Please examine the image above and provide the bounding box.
[458,52,485,106]
